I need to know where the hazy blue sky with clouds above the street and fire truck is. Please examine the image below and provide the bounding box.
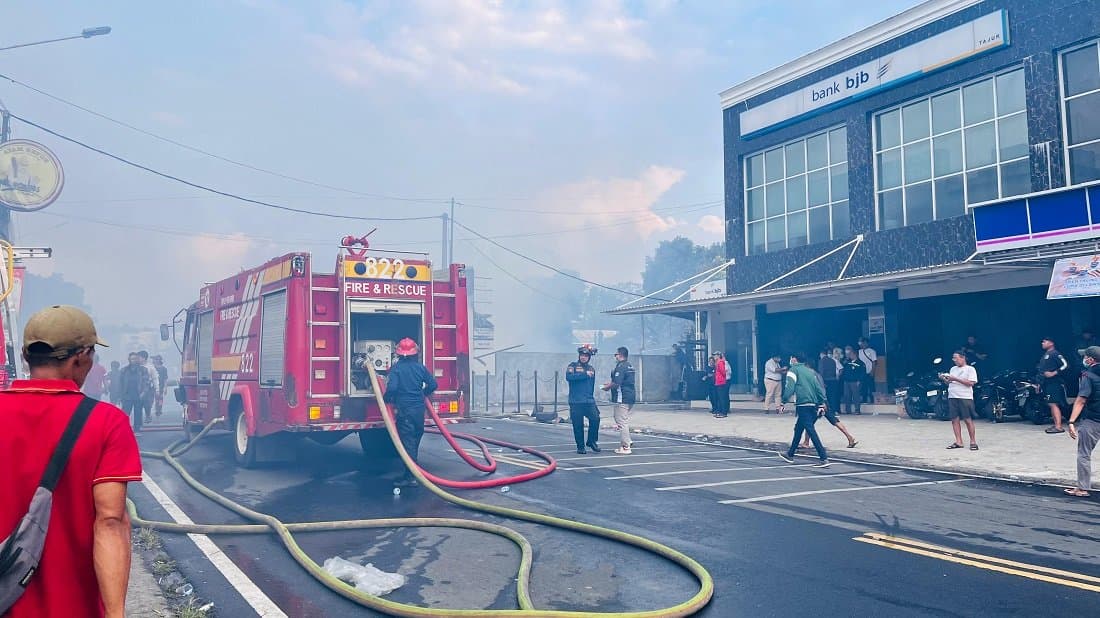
[0,0,916,344]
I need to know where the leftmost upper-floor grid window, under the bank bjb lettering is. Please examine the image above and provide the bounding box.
[745,126,849,255]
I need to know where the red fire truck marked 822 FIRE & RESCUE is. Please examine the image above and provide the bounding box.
[176,236,471,466]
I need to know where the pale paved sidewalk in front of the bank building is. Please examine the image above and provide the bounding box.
[624,401,1077,485]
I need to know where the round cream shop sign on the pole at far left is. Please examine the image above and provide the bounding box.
[0,140,65,212]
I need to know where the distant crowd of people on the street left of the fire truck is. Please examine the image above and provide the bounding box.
[83,350,168,435]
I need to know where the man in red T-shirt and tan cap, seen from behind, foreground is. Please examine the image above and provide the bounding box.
[0,306,142,618]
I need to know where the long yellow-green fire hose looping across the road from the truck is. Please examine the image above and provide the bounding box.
[128,365,714,618]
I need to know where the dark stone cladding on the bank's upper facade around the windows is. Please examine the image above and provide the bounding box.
[723,0,1100,294]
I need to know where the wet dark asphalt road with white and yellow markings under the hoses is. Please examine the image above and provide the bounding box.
[131,411,1100,617]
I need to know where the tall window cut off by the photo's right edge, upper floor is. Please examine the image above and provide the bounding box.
[1062,42,1100,185]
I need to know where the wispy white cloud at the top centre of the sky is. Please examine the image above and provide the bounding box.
[307,0,655,96]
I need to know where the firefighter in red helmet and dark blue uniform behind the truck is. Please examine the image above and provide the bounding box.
[384,338,439,487]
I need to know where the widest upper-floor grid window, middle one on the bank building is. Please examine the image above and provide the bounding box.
[875,69,1031,230]
